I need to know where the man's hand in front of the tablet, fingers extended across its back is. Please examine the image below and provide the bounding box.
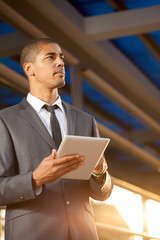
[32,149,84,188]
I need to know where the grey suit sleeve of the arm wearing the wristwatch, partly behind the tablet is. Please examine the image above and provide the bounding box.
[89,118,113,201]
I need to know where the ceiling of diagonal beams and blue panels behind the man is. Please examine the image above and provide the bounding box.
[0,0,160,195]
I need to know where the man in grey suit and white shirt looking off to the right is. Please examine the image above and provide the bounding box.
[0,39,113,240]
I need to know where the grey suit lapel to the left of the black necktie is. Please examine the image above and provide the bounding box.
[20,99,56,148]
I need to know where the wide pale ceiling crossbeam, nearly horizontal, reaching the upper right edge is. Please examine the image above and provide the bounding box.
[84,5,160,41]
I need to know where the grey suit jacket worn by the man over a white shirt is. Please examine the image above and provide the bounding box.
[0,99,112,240]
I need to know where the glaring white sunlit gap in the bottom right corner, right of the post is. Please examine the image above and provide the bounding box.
[146,200,160,238]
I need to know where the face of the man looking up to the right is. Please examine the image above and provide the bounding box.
[32,43,65,89]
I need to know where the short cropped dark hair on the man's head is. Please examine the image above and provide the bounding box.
[20,38,57,68]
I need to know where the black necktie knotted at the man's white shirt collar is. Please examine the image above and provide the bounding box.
[43,104,62,148]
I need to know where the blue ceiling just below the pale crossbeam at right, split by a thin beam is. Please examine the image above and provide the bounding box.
[111,31,160,89]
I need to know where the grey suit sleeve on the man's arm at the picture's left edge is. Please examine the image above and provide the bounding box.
[0,119,35,205]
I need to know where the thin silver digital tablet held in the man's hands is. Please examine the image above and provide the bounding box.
[57,135,110,180]
